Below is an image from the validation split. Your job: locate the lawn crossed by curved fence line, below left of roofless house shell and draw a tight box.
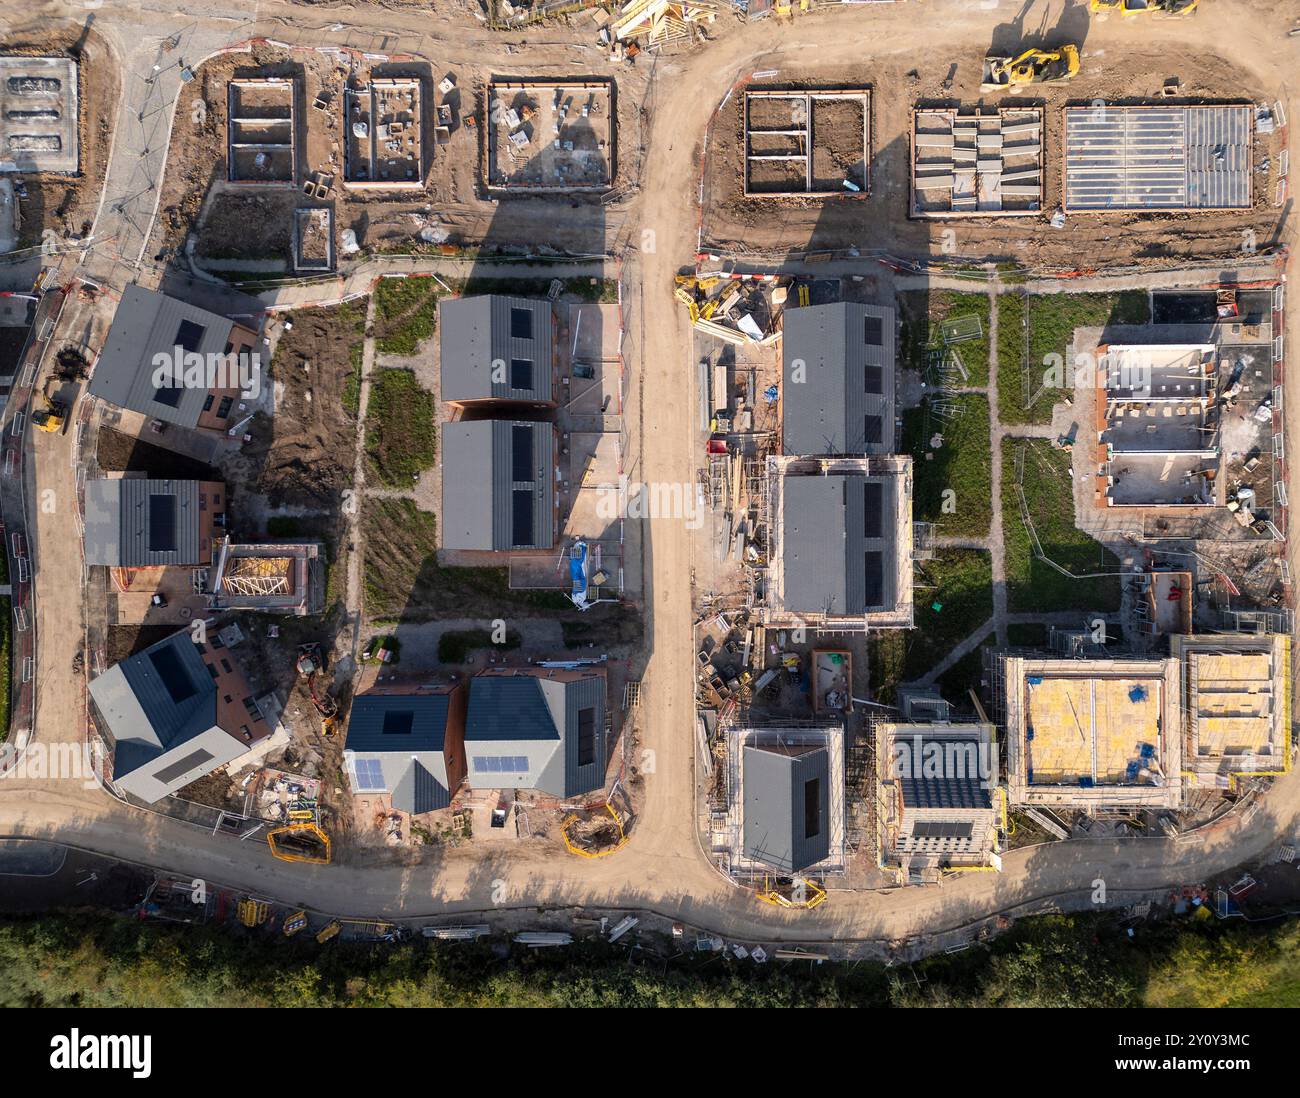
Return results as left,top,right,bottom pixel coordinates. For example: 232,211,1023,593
1002,439,1119,613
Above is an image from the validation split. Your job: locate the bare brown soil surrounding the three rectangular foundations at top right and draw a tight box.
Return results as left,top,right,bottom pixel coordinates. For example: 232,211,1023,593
701,50,1284,269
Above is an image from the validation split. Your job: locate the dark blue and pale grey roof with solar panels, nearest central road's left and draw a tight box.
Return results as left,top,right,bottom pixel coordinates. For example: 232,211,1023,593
465,674,606,798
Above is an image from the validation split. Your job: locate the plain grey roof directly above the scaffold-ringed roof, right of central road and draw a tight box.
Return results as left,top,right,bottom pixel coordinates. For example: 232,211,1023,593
781,301,894,456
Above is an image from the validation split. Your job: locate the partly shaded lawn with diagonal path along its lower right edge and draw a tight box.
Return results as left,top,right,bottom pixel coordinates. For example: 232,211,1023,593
868,550,993,704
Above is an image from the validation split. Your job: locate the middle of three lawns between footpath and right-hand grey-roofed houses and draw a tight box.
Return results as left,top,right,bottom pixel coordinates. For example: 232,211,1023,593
902,394,993,538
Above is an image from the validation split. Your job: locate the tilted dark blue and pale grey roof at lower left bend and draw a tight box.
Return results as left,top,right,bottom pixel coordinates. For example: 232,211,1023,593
90,630,217,781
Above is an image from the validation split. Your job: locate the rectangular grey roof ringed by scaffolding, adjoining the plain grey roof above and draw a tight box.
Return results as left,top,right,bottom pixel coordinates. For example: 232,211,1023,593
781,476,898,617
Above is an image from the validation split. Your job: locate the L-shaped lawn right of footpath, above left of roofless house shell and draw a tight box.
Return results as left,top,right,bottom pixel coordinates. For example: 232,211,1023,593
997,290,1151,424
